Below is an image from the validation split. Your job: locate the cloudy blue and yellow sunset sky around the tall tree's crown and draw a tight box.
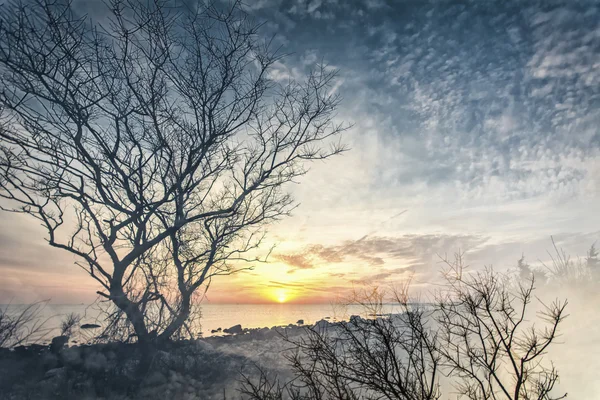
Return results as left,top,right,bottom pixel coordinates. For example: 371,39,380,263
0,0,600,303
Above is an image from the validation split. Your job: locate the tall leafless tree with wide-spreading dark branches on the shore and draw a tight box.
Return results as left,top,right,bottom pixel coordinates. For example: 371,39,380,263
0,0,345,343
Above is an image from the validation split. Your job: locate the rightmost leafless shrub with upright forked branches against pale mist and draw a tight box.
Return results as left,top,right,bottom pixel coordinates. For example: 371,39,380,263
436,254,567,400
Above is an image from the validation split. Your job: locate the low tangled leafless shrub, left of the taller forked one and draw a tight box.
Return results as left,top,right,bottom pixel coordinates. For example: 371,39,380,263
242,286,441,400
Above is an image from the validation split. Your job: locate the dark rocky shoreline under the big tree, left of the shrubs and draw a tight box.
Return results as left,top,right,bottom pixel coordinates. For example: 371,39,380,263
0,319,332,400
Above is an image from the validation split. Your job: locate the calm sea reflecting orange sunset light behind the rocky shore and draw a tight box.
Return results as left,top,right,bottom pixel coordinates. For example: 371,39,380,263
0,303,408,340
